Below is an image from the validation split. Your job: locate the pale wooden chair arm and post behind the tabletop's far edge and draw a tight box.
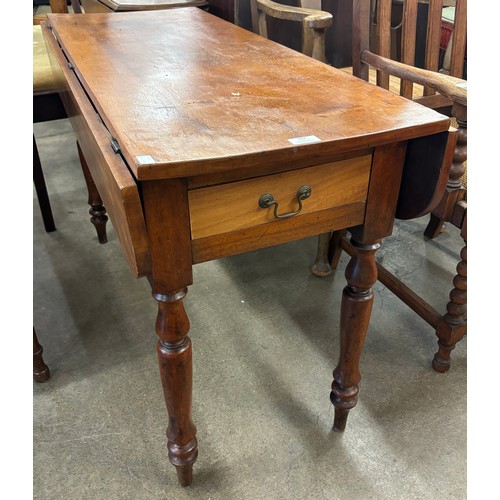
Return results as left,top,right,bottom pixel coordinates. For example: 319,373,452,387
250,0,332,62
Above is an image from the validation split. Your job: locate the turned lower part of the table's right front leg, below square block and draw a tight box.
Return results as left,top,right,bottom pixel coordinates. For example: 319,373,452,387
330,238,380,431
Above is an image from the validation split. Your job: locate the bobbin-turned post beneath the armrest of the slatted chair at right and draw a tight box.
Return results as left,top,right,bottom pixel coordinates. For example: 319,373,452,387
424,105,467,238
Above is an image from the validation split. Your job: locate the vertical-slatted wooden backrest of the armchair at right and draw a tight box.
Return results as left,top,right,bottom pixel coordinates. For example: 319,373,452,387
353,0,467,108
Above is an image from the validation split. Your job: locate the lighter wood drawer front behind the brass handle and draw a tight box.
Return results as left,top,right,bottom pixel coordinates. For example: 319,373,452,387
189,155,372,240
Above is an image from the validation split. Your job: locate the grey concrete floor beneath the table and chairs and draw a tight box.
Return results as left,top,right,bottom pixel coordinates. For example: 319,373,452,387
33,120,467,500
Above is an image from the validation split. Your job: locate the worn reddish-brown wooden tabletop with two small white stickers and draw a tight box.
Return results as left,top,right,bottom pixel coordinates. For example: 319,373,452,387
45,8,449,179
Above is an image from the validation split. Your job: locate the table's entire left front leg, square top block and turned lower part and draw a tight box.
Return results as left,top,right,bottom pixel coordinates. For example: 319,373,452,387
142,179,198,486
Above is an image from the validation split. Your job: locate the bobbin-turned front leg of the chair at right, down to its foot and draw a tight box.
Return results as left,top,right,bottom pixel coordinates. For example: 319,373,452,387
432,216,467,373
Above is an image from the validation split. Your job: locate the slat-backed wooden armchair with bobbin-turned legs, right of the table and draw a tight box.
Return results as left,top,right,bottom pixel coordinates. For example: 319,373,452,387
313,0,467,372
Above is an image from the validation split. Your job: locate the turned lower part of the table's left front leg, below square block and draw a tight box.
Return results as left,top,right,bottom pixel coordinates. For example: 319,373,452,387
154,289,198,486
